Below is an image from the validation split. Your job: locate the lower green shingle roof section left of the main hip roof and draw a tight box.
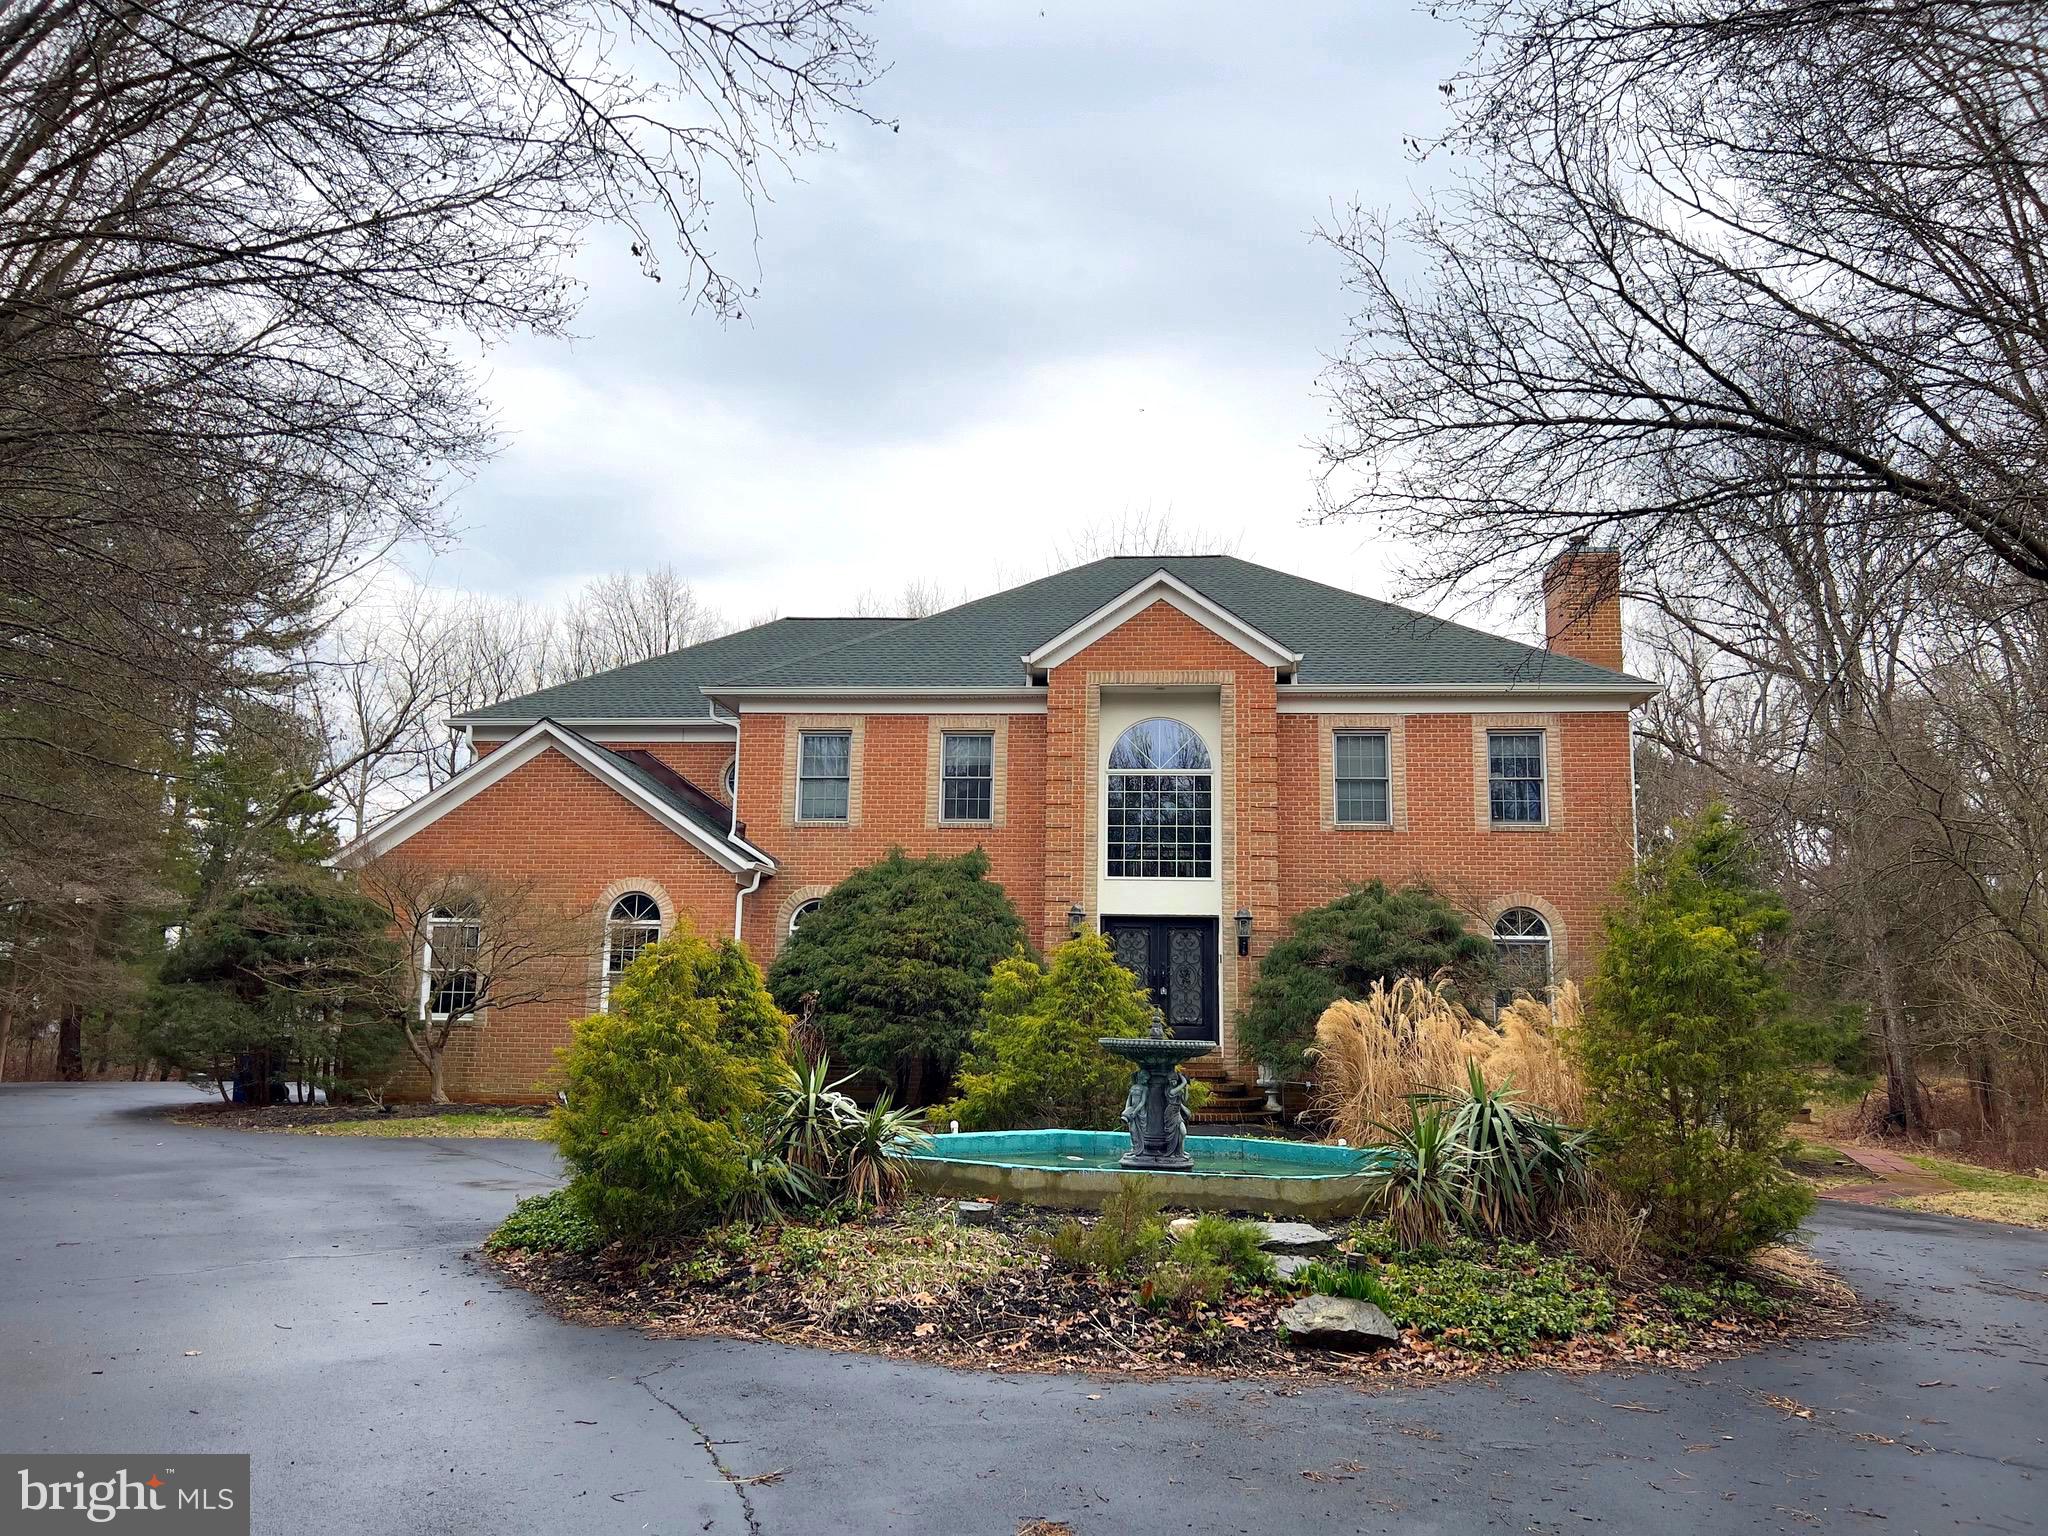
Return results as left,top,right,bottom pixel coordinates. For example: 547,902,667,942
461,618,909,721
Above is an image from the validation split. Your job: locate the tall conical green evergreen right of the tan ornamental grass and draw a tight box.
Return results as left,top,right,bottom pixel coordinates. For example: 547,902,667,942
1577,805,1815,1257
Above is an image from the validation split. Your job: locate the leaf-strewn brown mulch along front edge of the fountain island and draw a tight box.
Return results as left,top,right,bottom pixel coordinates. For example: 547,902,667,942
483,1206,1868,1386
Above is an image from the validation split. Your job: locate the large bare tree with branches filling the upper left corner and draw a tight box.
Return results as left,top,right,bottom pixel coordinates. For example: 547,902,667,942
0,0,874,888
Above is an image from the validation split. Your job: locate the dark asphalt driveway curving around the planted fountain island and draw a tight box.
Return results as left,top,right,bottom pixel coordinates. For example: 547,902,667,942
0,1085,2048,1536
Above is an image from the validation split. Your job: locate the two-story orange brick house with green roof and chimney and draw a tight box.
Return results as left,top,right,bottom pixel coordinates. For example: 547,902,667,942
342,549,1653,1100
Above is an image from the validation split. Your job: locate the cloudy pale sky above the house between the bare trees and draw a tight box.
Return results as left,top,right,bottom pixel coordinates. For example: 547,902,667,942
407,0,1507,634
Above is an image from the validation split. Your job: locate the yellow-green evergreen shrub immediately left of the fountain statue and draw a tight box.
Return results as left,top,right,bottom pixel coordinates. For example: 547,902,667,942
934,934,1151,1130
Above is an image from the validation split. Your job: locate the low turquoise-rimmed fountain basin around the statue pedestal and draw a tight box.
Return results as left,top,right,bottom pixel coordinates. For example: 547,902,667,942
911,1130,1384,1219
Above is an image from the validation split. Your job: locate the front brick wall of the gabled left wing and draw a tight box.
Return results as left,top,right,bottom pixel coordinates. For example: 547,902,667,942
380,750,735,1102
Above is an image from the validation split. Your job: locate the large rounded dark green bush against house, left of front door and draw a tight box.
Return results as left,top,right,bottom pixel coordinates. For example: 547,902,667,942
768,848,1024,1106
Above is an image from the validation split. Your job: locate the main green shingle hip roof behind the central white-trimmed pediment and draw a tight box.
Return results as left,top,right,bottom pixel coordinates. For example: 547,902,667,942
713,555,1655,690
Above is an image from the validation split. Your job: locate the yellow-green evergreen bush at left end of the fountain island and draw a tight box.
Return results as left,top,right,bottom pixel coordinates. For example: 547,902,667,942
555,928,788,1243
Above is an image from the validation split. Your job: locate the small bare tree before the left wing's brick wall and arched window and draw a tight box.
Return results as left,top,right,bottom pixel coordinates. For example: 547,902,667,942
358,856,604,1104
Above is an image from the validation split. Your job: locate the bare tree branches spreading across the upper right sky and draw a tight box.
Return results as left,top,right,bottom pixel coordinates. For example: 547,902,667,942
1325,0,2048,582
